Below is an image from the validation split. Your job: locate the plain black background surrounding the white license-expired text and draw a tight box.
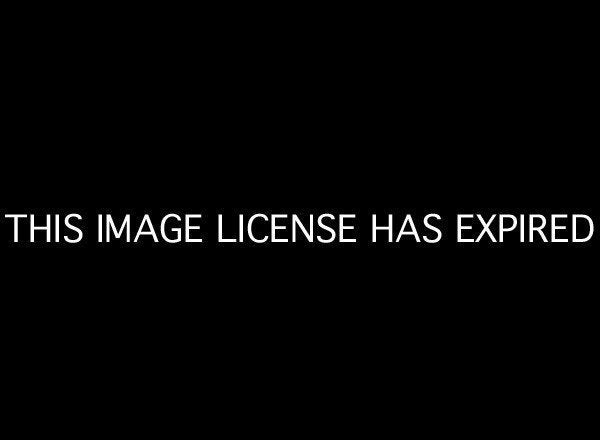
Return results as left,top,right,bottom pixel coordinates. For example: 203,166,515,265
1,5,598,433
